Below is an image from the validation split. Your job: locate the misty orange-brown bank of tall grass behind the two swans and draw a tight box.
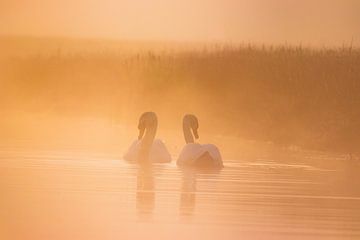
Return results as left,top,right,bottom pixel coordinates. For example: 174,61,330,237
0,37,360,152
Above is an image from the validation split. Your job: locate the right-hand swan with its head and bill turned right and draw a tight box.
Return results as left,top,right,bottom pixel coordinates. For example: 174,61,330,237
177,114,223,168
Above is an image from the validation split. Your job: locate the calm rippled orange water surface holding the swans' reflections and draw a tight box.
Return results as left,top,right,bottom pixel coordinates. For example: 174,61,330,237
0,143,360,240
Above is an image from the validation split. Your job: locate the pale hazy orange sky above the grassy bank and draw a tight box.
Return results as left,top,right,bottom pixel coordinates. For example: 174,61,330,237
0,0,360,45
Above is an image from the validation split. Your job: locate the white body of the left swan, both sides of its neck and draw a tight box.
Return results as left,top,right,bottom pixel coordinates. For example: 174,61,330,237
124,139,171,163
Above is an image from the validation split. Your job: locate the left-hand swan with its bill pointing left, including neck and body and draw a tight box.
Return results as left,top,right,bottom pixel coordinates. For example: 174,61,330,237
124,112,171,163
